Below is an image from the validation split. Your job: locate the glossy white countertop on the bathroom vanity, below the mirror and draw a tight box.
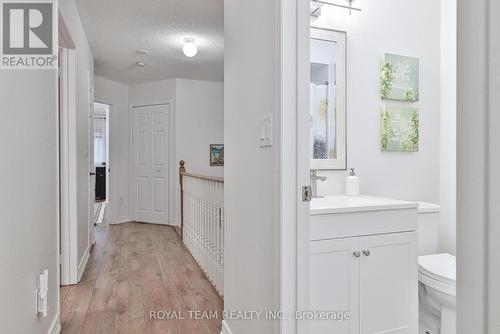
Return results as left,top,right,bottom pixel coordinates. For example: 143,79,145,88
311,195,419,215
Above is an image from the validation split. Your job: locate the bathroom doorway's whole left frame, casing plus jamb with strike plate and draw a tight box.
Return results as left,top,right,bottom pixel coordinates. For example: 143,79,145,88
275,0,310,334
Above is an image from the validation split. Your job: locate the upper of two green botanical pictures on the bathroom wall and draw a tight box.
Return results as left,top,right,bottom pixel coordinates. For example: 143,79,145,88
380,53,419,102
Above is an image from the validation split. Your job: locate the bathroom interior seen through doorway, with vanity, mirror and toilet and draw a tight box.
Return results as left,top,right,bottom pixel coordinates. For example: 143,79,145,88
309,0,457,334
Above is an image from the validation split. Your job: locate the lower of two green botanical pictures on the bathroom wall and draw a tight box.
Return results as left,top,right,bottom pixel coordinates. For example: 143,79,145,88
380,107,419,152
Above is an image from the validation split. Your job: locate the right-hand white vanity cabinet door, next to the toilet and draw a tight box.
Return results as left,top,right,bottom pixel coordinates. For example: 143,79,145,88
360,232,418,334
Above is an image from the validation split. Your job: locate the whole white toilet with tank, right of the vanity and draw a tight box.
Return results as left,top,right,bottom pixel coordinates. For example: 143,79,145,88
418,203,456,334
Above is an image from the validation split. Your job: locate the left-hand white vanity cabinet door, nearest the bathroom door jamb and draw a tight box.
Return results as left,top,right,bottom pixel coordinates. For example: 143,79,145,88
309,238,360,334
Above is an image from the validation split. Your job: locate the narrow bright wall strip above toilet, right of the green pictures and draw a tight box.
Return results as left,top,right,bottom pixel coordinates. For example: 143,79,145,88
439,0,457,255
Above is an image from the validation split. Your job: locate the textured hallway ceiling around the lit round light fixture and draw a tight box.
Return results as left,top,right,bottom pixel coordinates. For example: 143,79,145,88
77,0,224,84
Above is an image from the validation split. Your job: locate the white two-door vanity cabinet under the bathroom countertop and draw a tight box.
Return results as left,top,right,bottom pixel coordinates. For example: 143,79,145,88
309,196,418,334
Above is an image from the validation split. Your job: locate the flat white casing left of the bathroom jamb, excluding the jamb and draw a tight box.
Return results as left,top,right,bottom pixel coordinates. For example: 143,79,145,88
276,0,300,334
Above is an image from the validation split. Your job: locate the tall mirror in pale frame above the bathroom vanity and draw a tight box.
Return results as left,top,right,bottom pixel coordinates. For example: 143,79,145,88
309,28,347,170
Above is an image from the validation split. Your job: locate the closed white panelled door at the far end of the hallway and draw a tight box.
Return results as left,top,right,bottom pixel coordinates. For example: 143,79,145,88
132,104,170,224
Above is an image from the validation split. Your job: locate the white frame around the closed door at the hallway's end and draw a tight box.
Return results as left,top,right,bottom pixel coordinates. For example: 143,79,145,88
129,101,174,225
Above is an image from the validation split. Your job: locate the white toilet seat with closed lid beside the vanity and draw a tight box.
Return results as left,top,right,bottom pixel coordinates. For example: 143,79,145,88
418,253,457,296
